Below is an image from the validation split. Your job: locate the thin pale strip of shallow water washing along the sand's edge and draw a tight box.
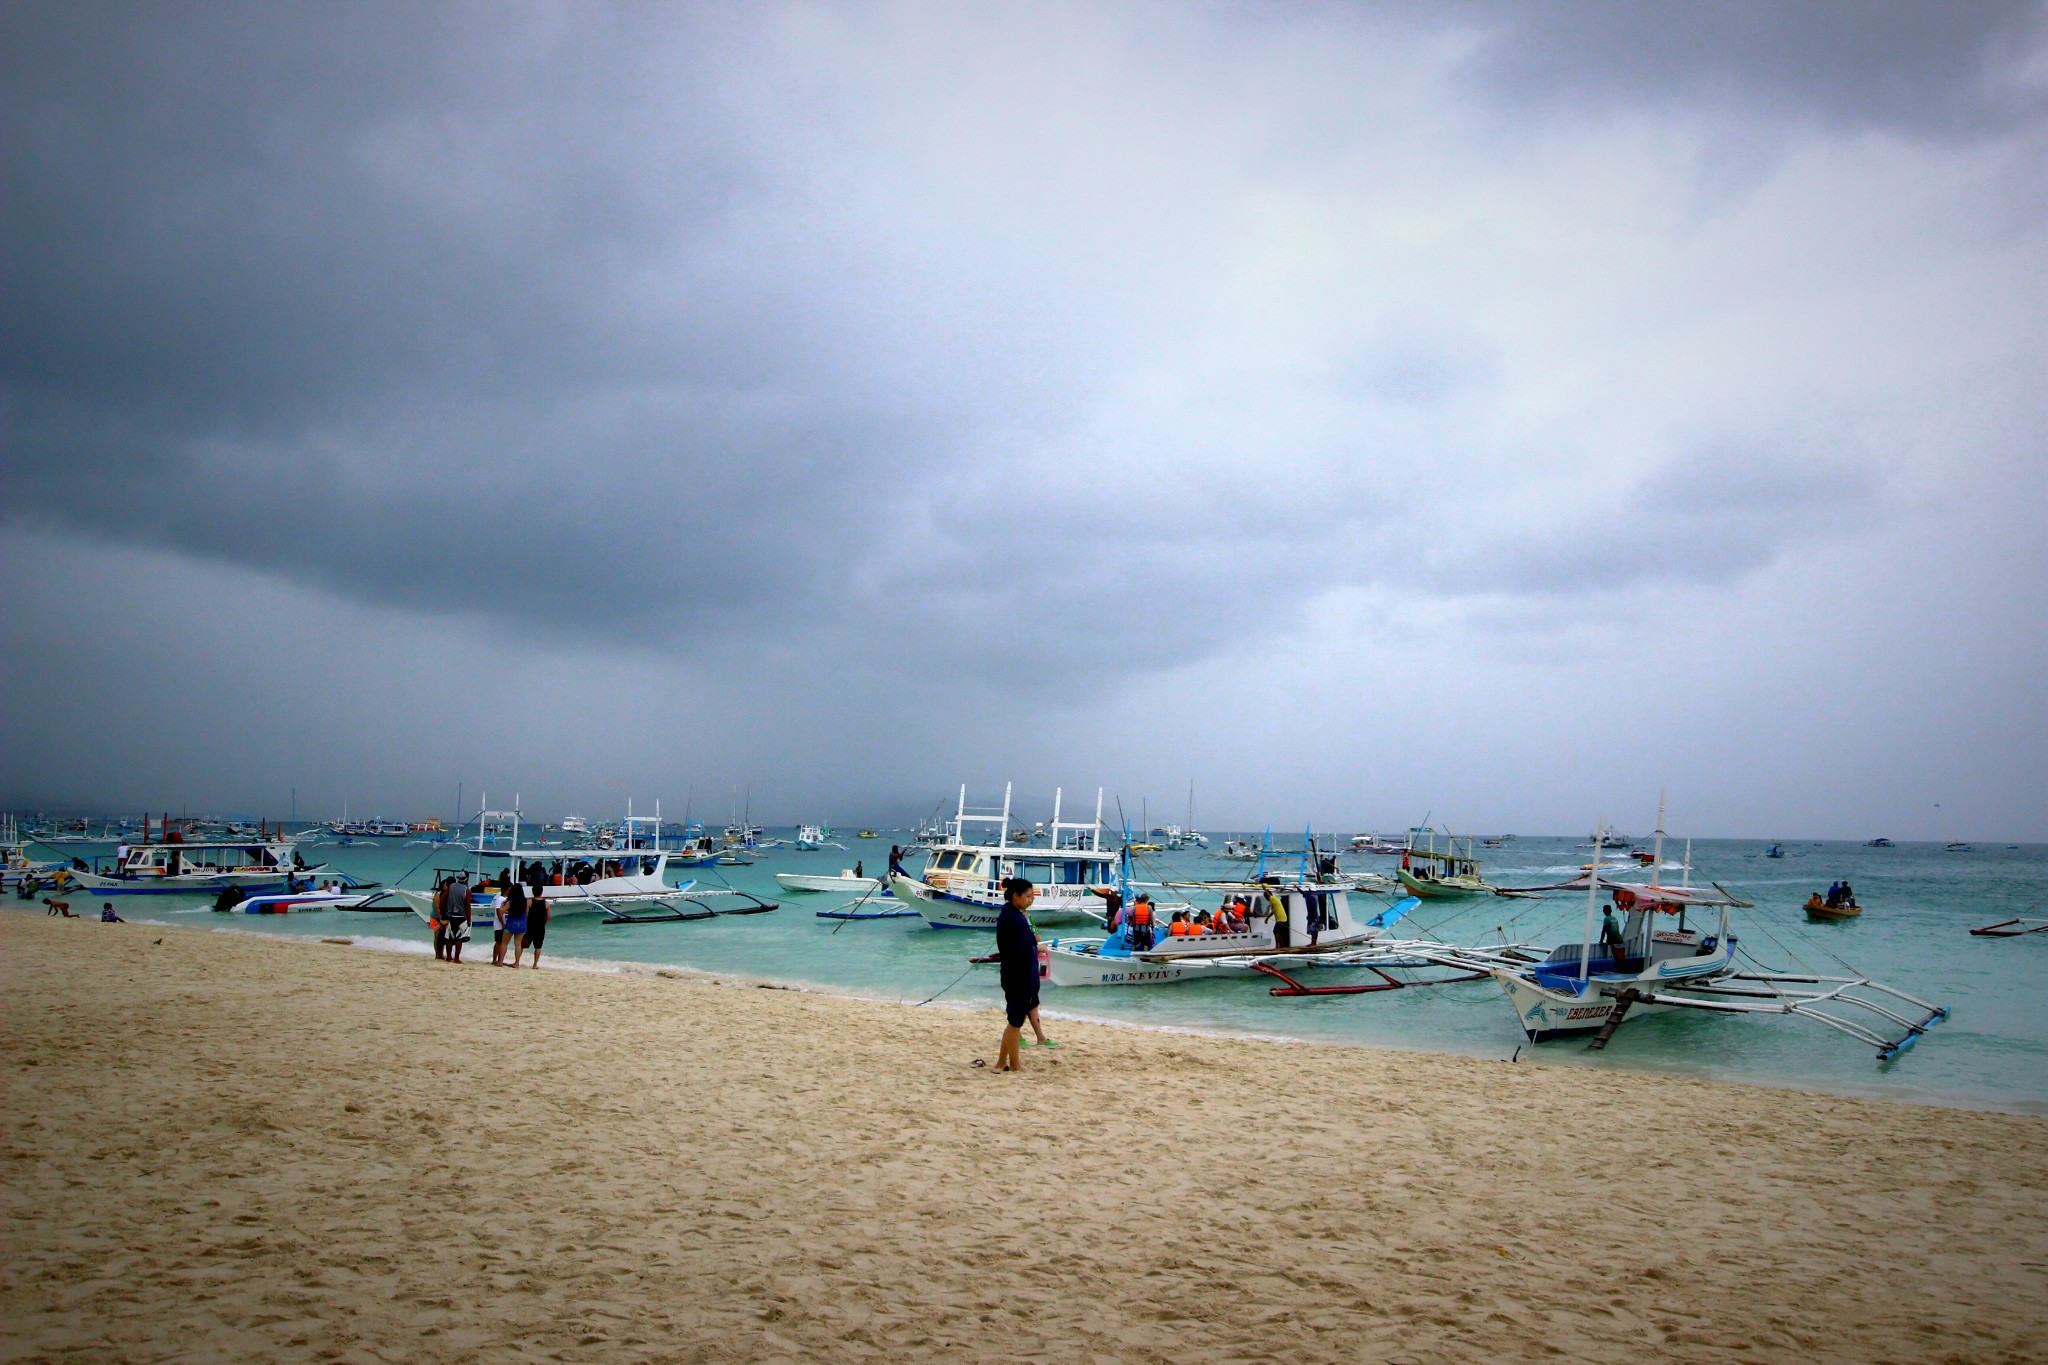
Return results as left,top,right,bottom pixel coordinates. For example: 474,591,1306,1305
151,919,2048,1119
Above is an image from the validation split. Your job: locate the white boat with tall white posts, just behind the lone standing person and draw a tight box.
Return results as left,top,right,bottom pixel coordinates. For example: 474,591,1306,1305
889,784,1118,929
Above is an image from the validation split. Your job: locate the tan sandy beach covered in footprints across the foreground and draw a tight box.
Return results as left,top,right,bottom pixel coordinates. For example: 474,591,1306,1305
0,915,2048,1361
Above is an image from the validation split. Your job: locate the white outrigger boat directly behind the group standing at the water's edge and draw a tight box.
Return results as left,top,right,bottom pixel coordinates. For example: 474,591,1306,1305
391,806,776,923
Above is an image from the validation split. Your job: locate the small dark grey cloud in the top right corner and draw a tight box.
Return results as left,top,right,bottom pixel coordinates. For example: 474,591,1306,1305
1473,0,2048,137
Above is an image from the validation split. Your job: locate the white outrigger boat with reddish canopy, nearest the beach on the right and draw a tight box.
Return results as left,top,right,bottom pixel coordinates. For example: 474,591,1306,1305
1419,819,1948,1062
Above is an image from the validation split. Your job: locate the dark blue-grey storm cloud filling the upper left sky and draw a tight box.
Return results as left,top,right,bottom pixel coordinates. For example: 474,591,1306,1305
0,6,974,642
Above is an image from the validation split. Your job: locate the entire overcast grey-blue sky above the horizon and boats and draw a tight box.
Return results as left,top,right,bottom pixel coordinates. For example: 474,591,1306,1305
0,2,2048,839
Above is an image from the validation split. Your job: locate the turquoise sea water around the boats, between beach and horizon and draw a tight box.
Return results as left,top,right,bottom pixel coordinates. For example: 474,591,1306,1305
24,831,2048,1113
